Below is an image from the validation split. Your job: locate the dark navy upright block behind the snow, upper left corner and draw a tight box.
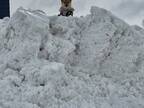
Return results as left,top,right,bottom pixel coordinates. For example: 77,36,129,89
0,0,10,19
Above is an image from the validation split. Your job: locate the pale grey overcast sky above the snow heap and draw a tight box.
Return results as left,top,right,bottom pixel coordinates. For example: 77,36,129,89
11,0,144,26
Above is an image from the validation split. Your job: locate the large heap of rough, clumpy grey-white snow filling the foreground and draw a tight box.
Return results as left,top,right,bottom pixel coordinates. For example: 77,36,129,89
0,7,144,108
